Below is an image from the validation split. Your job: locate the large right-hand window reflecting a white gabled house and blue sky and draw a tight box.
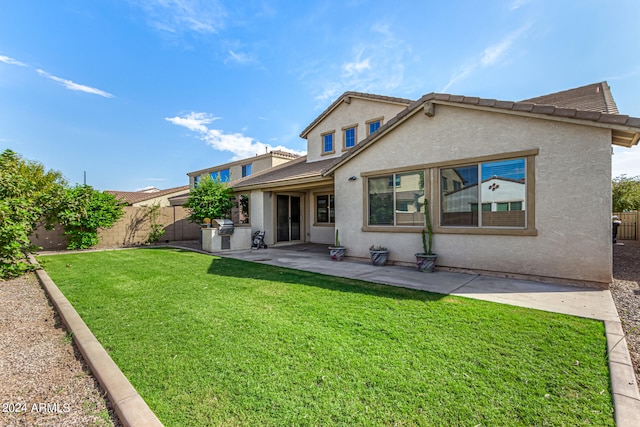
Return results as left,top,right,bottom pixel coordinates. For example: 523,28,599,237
439,158,527,228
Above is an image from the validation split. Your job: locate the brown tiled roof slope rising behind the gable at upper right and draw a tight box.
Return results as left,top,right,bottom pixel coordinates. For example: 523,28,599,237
520,82,619,114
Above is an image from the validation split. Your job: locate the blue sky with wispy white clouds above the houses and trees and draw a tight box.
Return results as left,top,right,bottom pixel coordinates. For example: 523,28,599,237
0,0,640,190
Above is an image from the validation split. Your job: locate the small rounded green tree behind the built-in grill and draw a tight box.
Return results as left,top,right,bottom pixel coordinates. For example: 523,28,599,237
185,177,235,223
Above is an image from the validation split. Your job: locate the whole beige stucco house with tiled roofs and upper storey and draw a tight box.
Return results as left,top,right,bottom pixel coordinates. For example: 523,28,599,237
232,82,640,285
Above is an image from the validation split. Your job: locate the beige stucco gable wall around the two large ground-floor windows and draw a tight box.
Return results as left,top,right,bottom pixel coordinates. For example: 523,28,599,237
335,105,612,283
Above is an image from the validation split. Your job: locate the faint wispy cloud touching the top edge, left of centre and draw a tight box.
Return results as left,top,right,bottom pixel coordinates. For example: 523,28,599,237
137,0,227,34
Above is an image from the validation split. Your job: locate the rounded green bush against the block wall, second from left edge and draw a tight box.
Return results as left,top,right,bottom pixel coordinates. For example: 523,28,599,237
58,185,123,249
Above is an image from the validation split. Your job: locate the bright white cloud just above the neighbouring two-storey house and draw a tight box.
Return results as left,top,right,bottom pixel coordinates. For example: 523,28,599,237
165,112,304,160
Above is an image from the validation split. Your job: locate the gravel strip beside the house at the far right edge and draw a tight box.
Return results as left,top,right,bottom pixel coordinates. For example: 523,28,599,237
611,240,640,384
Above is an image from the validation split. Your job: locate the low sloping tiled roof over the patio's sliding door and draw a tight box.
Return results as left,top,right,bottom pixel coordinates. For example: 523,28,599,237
232,156,339,190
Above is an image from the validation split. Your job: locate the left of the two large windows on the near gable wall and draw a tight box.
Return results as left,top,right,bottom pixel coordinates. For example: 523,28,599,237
367,171,425,227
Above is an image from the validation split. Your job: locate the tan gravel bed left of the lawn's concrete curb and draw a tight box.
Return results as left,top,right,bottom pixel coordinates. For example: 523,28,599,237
0,274,120,427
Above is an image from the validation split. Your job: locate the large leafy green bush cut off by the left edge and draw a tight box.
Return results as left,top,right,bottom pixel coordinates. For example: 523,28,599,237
0,149,66,279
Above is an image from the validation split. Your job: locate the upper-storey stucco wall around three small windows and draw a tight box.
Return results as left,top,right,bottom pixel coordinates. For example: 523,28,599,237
307,98,406,162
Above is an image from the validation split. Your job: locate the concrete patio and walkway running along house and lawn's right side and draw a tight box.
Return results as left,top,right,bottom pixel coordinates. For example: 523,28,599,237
196,244,640,427
